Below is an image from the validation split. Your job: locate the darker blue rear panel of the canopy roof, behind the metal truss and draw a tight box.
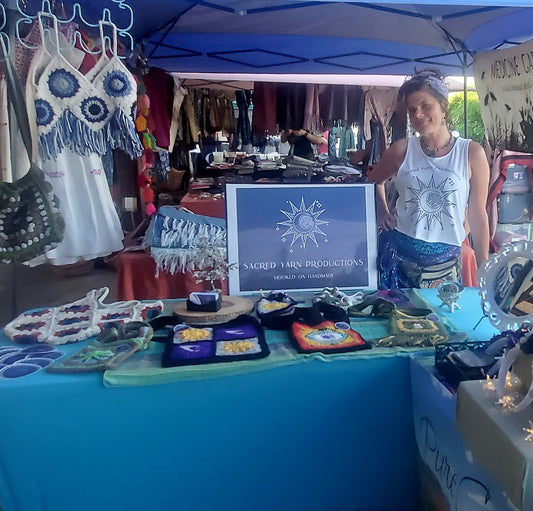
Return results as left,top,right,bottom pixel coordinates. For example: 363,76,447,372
143,34,461,74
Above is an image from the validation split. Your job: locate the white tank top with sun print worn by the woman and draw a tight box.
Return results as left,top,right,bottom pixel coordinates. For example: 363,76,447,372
395,137,470,246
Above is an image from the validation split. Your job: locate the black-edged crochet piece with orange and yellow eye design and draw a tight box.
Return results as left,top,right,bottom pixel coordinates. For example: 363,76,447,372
290,320,371,353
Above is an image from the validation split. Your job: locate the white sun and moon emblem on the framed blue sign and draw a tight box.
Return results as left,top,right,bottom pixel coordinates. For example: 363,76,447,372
276,197,329,252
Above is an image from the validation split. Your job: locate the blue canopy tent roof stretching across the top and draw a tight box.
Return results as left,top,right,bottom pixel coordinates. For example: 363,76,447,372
15,0,533,74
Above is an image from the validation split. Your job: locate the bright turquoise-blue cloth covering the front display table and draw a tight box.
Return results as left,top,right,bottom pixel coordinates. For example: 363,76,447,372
0,289,498,511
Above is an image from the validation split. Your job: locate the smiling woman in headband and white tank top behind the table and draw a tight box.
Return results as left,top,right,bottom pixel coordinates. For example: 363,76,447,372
368,70,489,288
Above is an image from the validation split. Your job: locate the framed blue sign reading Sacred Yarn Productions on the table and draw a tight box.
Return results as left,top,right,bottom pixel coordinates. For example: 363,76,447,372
226,184,377,295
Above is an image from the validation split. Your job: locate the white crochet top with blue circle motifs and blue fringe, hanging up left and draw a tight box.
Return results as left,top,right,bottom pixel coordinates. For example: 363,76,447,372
32,43,142,159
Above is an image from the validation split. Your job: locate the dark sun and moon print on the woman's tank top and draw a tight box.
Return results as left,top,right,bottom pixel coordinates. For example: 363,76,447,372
405,176,455,229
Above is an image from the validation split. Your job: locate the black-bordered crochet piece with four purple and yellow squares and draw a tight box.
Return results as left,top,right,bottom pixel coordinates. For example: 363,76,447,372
162,314,270,367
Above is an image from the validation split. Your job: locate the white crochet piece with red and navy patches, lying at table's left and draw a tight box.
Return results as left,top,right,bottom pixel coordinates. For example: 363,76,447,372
4,287,164,345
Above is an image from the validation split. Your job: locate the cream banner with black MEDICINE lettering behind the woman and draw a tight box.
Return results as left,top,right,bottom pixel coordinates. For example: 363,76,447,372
474,40,533,152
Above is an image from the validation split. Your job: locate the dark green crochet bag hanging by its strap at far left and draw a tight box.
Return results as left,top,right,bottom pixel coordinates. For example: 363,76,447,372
0,39,65,262
